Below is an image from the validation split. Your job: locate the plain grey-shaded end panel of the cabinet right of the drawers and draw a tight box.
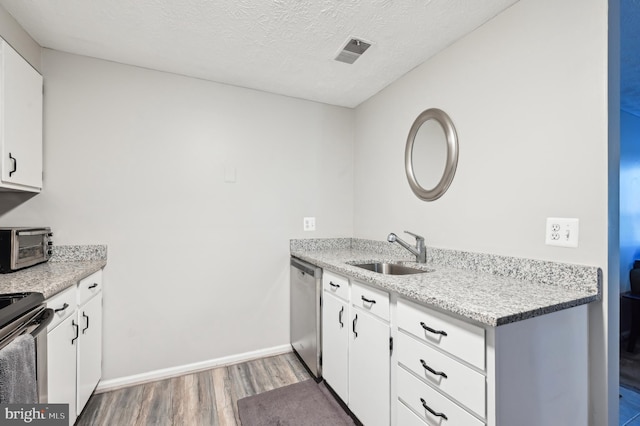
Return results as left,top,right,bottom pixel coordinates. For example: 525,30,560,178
487,305,589,426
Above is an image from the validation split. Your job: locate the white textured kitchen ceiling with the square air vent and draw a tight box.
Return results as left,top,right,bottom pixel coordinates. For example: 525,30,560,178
0,0,517,107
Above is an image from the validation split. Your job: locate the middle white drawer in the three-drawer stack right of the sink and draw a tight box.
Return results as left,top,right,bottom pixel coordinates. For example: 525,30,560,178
396,332,486,417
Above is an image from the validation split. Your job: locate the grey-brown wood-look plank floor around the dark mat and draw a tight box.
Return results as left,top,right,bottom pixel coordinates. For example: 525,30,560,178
76,353,310,426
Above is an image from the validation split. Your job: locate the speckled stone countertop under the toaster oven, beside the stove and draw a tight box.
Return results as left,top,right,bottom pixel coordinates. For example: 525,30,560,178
0,246,107,299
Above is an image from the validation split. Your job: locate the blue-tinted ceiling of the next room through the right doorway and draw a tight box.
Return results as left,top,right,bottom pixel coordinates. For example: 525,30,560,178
620,0,640,117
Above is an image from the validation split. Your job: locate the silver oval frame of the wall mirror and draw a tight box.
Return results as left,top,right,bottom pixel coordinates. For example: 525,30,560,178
404,108,458,201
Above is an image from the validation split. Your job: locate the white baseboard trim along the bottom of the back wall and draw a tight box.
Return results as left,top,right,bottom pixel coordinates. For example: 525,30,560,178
95,344,292,393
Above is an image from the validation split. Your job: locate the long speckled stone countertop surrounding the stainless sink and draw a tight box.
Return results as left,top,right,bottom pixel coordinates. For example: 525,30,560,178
291,238,602,326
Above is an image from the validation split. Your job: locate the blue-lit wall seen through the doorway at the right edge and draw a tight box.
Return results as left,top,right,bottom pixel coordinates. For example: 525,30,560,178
620,111,640,291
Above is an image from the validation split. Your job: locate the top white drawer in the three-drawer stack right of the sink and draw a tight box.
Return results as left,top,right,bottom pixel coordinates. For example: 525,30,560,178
398,300,485,370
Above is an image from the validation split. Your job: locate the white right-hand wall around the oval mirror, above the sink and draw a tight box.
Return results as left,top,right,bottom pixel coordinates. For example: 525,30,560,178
354,0,618,425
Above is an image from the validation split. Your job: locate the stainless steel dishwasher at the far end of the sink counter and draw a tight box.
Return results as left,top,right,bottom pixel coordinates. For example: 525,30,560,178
289,257,322,380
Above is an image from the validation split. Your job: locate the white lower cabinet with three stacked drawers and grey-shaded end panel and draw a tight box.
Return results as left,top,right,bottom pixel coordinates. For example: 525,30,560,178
393,300,588,426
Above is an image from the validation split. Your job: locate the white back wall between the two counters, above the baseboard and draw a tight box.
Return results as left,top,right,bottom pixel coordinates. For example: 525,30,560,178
0,49,354,379
